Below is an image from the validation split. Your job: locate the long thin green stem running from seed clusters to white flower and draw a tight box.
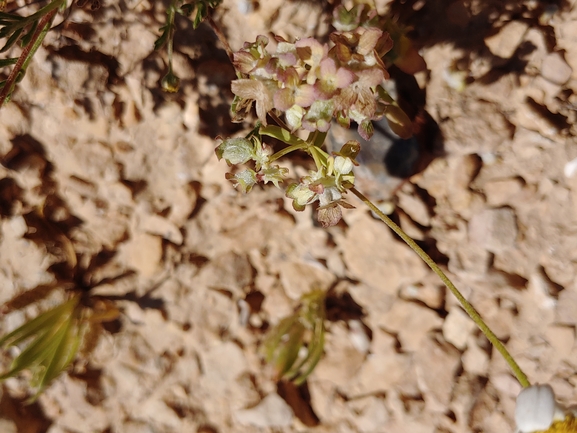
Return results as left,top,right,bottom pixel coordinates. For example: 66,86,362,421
351,187,531,387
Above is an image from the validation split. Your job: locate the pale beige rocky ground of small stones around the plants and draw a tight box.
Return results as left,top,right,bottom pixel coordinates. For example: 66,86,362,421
0,0,577,433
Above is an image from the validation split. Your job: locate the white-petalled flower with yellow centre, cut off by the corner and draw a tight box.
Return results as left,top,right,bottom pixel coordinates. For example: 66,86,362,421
515,385,577,433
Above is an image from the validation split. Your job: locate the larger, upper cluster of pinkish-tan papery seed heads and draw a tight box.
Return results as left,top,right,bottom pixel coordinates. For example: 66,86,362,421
232,27,412,140
